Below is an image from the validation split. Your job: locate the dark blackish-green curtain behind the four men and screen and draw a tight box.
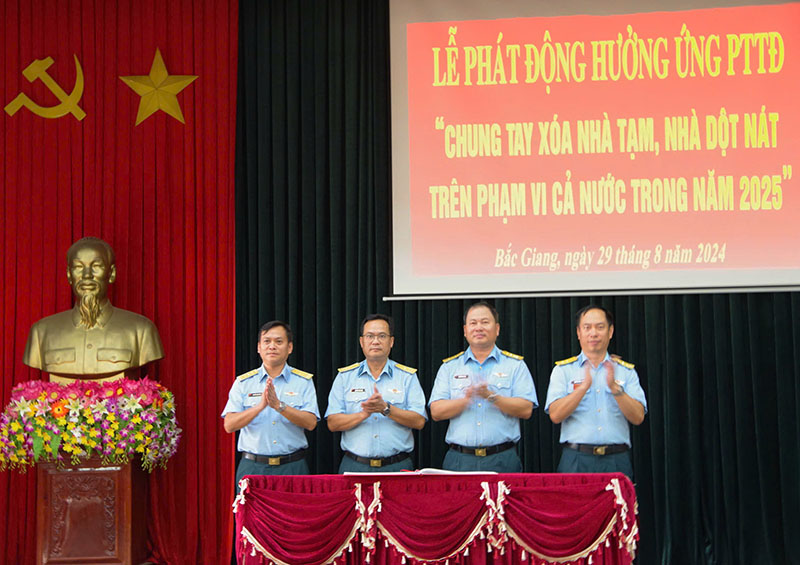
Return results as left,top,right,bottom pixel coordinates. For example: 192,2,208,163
230,0,800,564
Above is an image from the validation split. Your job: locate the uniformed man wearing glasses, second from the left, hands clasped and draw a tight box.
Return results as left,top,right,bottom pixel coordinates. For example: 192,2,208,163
325,314,427,473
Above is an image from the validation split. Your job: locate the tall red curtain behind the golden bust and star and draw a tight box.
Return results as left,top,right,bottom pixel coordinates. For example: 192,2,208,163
0,0,238,564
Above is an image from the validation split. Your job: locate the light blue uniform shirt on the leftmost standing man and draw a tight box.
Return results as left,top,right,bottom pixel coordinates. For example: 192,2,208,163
222,365,319,456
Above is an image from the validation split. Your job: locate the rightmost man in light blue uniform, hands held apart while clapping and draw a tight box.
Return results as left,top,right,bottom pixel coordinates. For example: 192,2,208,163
544,305,647,479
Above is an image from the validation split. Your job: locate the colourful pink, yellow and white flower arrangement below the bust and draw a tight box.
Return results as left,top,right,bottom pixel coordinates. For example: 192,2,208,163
0,379,181,471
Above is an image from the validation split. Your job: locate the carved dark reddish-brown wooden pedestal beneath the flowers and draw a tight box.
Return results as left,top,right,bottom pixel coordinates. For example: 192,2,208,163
36,459,147,565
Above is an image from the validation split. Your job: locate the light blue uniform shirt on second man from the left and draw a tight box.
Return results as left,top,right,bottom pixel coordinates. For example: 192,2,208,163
325,359,428,458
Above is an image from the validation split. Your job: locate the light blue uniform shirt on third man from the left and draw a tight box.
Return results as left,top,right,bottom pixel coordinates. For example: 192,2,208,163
428,346,539,447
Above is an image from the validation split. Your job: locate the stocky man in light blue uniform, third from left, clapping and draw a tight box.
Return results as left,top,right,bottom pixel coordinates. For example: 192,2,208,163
430,301,538,473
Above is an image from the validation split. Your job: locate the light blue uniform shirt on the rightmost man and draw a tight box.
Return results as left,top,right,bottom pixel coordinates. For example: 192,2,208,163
544,352,647,446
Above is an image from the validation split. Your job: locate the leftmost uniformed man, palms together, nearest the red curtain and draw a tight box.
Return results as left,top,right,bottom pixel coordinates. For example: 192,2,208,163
222,320,319,485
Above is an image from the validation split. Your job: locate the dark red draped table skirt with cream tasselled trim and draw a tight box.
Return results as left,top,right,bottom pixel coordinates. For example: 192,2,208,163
234,473,639,565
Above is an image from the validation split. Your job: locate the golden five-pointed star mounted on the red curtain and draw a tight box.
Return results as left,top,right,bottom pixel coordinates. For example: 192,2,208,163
119,48,197,126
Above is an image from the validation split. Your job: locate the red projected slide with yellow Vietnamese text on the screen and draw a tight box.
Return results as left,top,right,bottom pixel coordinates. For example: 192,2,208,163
395,4,800,293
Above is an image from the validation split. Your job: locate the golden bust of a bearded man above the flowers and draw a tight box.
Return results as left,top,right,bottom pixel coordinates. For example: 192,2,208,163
22,237,164,382
